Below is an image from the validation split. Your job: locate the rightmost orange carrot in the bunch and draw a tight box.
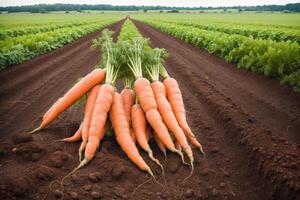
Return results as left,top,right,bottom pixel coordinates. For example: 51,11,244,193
163,77,205,155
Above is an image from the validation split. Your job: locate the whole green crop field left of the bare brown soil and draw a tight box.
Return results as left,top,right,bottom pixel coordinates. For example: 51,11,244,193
0,14,122,70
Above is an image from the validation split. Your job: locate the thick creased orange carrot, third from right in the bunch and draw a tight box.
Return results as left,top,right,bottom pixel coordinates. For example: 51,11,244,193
134,78,184,162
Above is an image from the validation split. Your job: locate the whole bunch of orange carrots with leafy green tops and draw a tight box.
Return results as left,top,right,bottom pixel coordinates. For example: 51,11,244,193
31,20,204,184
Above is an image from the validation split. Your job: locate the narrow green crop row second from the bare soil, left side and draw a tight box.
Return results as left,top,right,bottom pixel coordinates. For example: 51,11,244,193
0,22,102,40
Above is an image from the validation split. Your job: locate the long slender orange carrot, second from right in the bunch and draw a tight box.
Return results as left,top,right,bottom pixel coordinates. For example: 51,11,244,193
151,81,194,170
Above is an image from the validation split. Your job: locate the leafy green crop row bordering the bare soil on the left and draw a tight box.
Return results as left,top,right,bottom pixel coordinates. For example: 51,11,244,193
0,19,117,70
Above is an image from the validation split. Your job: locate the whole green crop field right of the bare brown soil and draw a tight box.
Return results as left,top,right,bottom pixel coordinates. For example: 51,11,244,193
134,14,300,91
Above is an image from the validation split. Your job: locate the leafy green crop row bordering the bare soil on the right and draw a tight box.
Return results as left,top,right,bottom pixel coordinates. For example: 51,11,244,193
139,20,300,91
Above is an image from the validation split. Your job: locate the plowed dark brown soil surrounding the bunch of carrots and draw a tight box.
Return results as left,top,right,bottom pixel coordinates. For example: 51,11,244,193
0,21,300,200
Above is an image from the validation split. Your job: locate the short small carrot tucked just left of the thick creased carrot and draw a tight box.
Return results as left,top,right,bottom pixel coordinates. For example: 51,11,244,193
131,104,164,174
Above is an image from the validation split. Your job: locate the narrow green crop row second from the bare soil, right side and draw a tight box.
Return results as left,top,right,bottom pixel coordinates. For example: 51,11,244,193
171,22,300,44
